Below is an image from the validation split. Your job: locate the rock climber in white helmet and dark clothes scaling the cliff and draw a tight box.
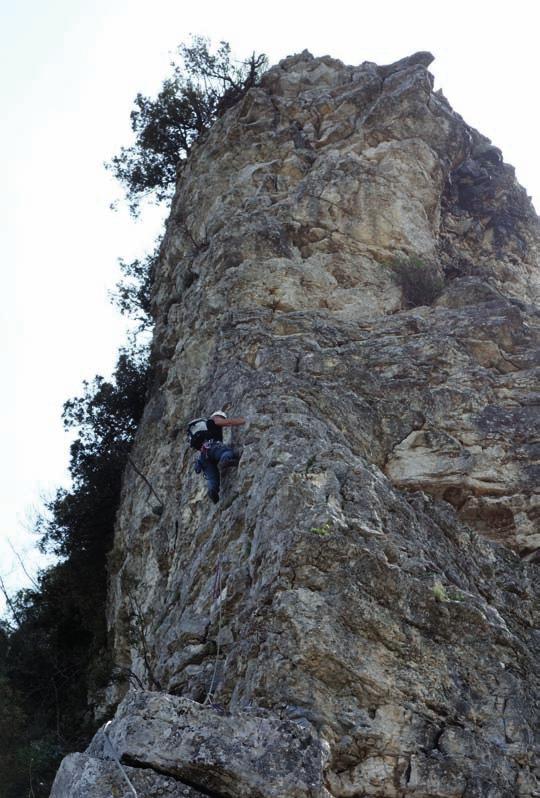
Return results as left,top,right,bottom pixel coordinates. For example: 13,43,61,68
187,410,246,504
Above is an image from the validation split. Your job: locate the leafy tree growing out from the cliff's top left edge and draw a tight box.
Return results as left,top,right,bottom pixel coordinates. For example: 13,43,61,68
107,36,267,214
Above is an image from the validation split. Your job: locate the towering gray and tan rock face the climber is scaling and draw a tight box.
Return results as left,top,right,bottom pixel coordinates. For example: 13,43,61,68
53,52,540,798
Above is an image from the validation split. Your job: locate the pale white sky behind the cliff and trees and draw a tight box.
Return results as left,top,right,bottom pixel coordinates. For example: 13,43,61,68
0,0,540,612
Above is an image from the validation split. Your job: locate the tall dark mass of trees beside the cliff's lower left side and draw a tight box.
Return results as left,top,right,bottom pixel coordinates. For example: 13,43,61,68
0,349,148,798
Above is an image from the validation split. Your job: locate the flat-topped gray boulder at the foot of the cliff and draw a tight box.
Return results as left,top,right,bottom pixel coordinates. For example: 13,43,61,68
100,692,328,798
